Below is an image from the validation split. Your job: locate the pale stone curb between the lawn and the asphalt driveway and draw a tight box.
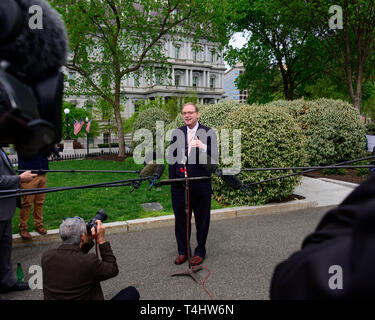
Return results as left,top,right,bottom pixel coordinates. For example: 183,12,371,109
12,200,318,247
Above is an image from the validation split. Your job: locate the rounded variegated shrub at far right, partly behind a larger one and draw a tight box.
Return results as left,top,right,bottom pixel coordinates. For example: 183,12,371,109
264,99,366,166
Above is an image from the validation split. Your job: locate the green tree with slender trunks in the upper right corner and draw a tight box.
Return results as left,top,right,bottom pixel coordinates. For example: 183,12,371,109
281,0,375,111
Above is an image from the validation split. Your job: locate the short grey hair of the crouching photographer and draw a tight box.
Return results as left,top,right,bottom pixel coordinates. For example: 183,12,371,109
59,217,87,245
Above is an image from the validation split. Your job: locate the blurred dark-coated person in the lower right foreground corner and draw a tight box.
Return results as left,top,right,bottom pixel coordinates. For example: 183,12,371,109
270,174,375,300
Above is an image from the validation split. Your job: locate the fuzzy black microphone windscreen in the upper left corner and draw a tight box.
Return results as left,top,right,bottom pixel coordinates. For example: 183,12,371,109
0,0,68,80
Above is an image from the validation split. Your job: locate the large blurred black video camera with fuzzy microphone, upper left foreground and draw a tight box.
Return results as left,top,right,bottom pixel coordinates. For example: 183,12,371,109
0,0,68,157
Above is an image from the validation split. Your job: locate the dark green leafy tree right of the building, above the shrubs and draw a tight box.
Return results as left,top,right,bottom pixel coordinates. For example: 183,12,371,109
226,0,324,103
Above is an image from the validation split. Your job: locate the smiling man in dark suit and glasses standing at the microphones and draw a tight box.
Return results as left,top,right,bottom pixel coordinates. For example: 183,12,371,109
168,102,217,266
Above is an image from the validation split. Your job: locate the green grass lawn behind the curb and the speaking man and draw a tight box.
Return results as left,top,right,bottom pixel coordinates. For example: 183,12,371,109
13,157,228,233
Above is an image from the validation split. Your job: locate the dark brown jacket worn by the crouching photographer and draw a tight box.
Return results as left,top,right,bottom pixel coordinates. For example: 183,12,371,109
42,242,118,300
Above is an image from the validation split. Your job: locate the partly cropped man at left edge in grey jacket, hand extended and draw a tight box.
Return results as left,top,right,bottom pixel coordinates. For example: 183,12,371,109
0,148,36,293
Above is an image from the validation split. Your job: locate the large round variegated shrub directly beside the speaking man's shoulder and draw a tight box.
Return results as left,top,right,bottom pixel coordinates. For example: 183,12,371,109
213,105,307,205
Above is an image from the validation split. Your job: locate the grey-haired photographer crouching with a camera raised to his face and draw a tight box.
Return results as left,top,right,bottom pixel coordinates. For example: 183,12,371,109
42,210,139,300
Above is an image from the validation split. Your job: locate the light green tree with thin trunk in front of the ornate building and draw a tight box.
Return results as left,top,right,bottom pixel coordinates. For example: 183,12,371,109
51,0,225,156
